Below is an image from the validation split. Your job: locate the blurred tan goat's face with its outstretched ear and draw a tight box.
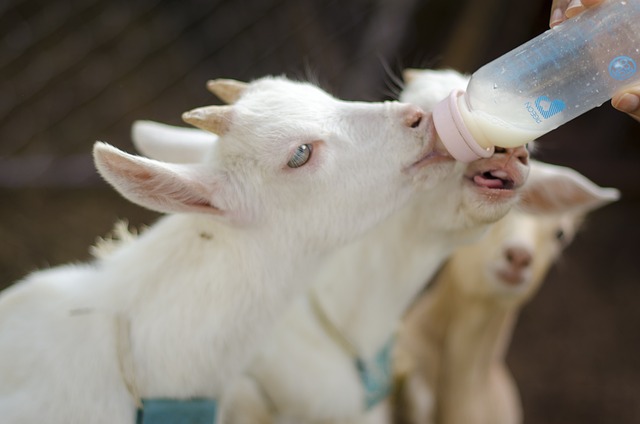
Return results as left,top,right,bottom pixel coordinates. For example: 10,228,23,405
442,161,619,304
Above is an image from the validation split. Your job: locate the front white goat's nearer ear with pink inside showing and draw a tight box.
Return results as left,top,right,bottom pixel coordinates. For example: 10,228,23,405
93,142,238,216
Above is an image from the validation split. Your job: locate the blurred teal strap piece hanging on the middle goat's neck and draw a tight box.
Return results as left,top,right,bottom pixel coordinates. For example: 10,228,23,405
356,338,395,410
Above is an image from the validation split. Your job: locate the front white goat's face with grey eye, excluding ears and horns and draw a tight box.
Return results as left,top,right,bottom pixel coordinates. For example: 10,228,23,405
202,78,451,248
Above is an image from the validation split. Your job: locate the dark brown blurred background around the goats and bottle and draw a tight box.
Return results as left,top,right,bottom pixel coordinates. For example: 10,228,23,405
0,0,640,424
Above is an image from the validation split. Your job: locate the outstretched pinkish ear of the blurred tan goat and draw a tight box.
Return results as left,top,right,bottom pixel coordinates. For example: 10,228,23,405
518,161,620,217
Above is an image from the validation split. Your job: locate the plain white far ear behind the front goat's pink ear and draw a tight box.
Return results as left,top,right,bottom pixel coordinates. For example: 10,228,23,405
131,121,218,163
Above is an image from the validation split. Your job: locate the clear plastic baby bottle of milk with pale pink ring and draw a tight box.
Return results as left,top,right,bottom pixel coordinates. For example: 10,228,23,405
433,0,640,162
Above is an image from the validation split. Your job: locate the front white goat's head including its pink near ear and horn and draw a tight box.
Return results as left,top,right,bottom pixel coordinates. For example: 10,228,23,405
96,77,452,248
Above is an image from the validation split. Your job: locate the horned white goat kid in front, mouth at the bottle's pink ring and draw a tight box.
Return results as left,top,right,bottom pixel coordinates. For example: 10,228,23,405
0,78,441,424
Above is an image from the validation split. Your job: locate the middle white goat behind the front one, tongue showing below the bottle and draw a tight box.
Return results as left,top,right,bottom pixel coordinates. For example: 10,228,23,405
134,70,528,423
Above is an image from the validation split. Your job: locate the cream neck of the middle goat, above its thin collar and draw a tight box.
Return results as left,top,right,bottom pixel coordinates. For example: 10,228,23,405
313,185,484,358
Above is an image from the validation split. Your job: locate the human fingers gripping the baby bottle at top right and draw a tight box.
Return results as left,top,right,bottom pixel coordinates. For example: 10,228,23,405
549,0,640,122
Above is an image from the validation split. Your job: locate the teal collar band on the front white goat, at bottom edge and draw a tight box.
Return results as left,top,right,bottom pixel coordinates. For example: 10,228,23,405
136,399,217,424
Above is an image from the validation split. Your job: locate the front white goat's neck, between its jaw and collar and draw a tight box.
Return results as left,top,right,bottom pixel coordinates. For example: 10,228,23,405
99,214,313,397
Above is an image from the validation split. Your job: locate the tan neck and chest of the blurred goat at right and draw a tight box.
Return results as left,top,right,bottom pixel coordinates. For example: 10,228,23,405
423,267,518,424
